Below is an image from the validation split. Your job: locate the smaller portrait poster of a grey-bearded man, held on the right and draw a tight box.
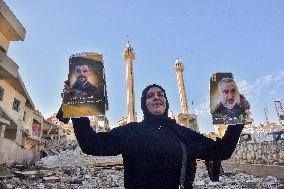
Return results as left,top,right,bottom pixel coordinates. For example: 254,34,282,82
210,73,246,124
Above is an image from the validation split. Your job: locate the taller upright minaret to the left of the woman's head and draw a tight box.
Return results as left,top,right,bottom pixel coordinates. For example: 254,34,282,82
123,41,136,123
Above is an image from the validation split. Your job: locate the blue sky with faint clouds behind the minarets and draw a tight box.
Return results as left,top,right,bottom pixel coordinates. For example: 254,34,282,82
4,0,284,133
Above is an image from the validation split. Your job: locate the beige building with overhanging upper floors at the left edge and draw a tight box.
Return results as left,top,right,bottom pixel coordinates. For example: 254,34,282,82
0,0,43,163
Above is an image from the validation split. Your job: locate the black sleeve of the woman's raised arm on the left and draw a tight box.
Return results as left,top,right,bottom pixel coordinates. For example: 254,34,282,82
72,117,123,156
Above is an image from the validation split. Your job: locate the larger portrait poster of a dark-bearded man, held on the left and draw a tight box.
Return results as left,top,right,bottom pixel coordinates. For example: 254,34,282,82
63,52,108,118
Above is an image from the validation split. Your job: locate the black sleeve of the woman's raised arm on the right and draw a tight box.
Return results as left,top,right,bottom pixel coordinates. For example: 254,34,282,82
184,124,244,161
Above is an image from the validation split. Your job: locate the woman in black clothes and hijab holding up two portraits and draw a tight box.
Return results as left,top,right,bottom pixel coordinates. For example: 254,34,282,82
58,84,246,189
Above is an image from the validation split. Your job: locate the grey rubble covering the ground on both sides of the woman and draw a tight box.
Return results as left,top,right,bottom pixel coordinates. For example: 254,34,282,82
0,142,284,189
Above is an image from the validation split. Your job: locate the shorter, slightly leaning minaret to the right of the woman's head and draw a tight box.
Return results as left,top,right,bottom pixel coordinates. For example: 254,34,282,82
175,58,188,114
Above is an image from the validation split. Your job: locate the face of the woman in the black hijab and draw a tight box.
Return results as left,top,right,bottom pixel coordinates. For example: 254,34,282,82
146,87,166,115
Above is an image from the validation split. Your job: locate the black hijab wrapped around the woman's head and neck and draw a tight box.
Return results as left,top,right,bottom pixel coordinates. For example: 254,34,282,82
141,84,173,125
